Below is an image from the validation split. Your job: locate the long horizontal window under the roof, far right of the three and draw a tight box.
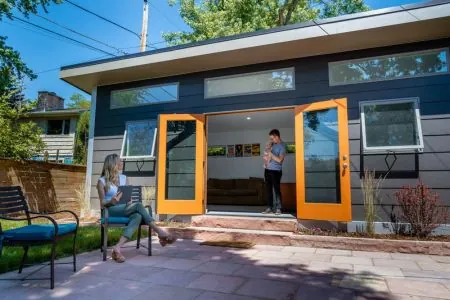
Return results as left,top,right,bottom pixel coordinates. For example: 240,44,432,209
328,48,450,86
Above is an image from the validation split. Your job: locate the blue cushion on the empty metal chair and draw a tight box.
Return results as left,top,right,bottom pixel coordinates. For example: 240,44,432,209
3,223,77,241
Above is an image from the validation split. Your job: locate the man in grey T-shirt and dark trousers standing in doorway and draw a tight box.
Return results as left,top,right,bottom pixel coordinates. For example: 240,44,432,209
263,129,286,215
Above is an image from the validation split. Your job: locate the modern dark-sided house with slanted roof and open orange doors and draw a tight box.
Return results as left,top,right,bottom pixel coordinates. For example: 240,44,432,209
60,1,450,230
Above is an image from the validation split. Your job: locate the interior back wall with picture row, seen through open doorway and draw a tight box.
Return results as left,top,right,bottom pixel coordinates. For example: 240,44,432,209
208,127,295,183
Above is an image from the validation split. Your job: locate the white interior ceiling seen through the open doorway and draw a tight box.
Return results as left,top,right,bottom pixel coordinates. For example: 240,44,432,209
208,109,294,132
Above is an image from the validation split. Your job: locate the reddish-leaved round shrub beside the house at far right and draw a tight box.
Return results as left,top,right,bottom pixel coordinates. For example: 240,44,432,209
395,182,449,237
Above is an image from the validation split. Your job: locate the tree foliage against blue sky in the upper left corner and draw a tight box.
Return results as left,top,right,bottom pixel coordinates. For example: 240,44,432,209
0,0,62,95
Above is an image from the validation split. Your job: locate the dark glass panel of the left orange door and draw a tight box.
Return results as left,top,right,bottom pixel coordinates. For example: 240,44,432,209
165,121,196,200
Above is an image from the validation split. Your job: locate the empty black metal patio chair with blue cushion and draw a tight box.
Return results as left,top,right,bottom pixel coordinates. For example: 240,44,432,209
0,186,79,289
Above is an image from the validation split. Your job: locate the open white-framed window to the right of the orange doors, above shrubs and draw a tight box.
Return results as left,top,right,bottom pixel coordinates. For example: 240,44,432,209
360,98,423,153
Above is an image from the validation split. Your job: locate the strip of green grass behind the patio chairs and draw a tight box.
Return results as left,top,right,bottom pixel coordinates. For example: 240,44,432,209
0,221,147,273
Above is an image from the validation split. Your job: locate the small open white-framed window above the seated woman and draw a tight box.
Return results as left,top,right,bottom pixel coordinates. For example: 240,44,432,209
120,120,158,160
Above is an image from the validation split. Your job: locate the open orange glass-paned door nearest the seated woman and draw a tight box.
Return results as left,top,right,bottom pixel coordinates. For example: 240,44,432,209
156,114,205,215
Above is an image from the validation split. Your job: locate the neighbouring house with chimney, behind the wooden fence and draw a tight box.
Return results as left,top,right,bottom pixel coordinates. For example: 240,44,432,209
27,91,86,164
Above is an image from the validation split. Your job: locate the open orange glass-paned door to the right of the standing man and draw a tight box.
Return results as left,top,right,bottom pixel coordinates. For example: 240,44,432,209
295,99,352,221
